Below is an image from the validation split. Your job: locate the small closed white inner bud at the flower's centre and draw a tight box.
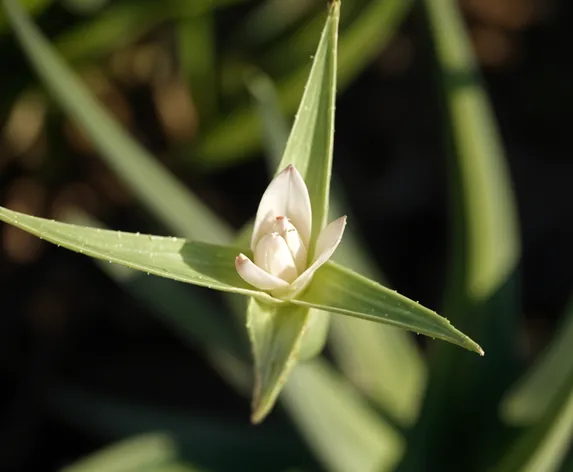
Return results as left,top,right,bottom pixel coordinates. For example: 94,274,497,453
255,233,298,282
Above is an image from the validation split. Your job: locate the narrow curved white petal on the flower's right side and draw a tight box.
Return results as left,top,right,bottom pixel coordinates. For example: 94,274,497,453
272,216,346,299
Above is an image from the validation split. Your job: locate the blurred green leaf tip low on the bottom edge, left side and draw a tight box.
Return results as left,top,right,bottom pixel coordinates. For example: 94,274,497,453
60,433,177,472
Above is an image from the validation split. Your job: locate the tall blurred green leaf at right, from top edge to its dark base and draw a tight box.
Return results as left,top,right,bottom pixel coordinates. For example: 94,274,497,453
400,0,519,472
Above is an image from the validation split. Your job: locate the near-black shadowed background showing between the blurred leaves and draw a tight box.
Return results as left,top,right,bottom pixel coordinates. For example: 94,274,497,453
0,0,573,470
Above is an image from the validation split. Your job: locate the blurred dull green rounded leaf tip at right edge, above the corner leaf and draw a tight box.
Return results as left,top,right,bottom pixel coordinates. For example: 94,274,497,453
501,299,573,426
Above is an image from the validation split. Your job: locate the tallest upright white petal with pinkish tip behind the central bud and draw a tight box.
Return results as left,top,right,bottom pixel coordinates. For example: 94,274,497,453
251,165,312,251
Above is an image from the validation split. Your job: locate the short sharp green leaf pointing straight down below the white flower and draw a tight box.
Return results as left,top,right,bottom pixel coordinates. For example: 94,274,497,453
247,298,309,423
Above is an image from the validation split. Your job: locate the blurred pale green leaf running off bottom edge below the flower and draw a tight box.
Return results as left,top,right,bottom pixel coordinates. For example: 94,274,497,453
283,359,404,472
